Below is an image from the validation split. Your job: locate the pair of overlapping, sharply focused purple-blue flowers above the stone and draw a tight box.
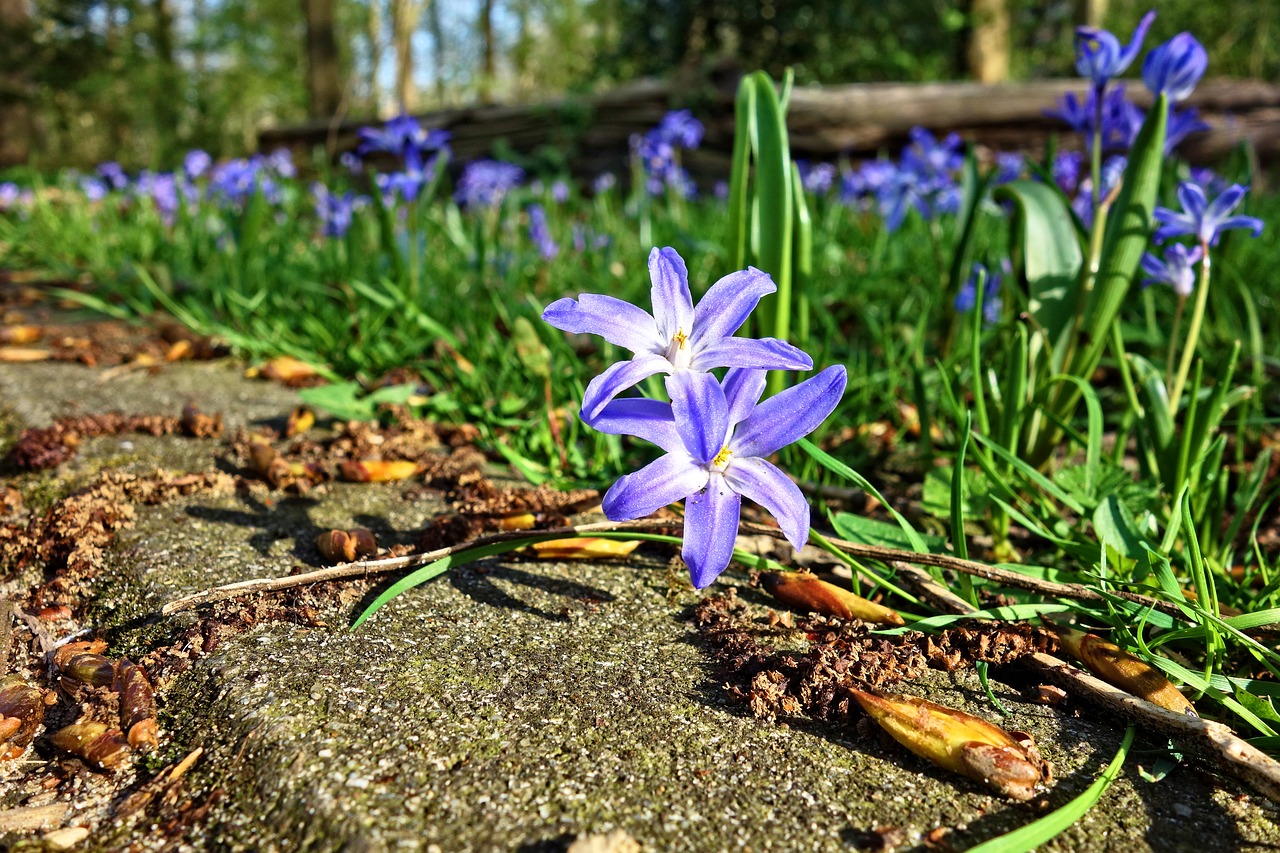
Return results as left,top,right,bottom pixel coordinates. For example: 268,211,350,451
543,248,846,589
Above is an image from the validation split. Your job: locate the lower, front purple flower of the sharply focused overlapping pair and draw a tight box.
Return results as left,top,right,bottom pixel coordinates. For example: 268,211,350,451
593,365,847,589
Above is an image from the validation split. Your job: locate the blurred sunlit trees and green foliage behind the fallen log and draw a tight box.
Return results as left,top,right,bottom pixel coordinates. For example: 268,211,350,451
0,0,1280,168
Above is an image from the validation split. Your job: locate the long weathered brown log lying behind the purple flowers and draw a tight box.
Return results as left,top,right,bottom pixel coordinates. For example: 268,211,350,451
259,79,1280,182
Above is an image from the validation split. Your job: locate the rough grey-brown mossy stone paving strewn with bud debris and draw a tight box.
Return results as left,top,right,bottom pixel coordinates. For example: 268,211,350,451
0,364,1280,852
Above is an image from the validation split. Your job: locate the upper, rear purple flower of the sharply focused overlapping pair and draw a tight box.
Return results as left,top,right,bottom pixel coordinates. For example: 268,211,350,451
543,247,813,417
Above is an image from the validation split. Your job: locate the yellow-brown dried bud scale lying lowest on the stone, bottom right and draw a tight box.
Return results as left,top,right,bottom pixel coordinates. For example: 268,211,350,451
850,689,1044,800
